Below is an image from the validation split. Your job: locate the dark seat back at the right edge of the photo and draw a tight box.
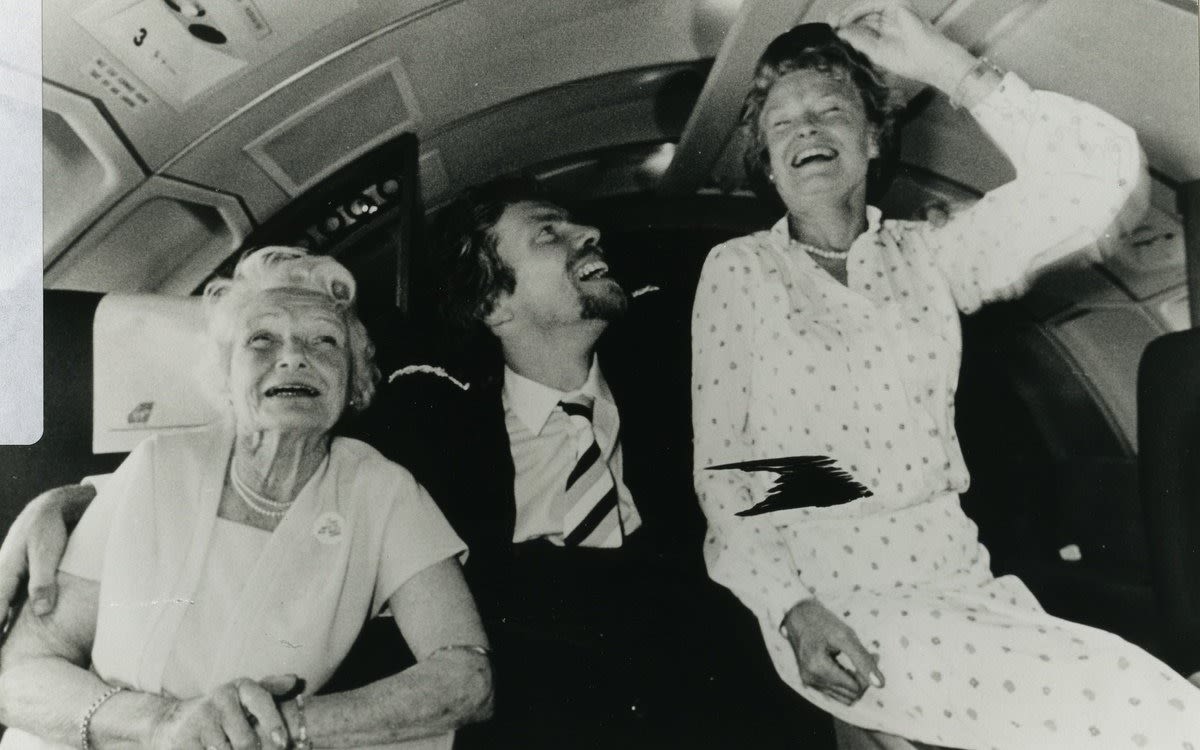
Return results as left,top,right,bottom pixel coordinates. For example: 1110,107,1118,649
1138,329,1200,674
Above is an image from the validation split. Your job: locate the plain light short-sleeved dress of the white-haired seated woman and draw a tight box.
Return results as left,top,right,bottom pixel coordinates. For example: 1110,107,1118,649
2,427,466,750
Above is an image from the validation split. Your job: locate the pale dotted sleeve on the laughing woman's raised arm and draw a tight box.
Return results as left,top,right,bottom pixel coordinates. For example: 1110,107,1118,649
922,73,1150,312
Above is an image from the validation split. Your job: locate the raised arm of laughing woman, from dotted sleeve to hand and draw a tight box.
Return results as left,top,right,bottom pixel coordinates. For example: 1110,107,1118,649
838,0,1150,312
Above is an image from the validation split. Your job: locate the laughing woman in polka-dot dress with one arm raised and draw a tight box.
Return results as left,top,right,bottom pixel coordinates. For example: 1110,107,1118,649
692,0,1200,750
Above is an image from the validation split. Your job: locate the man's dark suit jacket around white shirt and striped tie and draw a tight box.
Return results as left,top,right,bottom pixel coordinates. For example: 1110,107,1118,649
328,285,825,748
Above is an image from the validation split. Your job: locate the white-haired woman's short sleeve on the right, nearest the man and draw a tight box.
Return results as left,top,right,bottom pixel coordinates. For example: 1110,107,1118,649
371,467,467,617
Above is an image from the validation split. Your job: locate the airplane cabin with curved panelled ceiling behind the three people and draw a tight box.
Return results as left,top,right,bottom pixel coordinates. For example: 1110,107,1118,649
0,0,1200,744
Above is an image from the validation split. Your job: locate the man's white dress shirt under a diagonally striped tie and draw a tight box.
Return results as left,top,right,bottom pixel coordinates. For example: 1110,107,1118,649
503,358,642,544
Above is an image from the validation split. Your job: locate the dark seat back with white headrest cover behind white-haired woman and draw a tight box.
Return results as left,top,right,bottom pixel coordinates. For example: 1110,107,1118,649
0,289,220,529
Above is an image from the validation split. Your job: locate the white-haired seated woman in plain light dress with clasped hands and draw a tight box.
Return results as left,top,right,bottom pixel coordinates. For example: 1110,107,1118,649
0,247,491,749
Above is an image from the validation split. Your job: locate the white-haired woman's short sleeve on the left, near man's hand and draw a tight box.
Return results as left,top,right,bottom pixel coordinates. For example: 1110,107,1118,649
59,437,155,581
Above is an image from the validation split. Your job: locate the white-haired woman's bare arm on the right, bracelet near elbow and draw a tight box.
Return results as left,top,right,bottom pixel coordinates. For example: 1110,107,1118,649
283,558,492,748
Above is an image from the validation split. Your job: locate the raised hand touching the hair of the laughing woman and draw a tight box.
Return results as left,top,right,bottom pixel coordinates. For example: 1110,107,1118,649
829,0,977,94
